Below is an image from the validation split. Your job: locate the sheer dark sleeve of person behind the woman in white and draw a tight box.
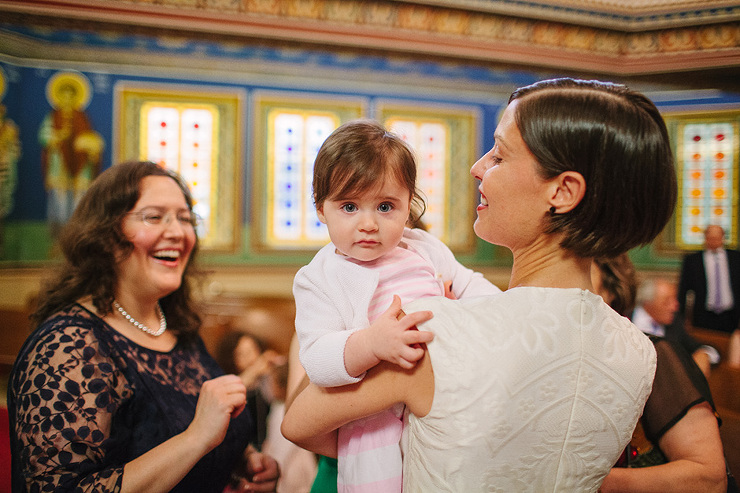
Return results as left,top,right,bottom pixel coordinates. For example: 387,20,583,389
642,338,714,444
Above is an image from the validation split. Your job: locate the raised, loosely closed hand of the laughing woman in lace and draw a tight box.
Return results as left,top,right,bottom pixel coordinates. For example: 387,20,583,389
186,375,247,452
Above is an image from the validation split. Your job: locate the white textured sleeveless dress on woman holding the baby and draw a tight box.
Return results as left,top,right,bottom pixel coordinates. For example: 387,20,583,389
402,287,656,493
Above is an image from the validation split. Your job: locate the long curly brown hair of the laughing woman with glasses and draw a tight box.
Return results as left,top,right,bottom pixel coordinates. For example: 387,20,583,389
31,161,201,335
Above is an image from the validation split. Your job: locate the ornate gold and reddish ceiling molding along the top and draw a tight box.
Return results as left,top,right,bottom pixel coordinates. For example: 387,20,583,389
0,0,740,75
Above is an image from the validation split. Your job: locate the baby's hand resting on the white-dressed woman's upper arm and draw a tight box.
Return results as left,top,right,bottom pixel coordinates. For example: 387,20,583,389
367,296,434,370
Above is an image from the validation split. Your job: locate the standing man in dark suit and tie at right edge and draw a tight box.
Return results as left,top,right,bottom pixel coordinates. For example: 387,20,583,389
678,225,740,333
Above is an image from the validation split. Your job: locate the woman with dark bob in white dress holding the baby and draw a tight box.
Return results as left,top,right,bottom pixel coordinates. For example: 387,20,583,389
283,79,676,493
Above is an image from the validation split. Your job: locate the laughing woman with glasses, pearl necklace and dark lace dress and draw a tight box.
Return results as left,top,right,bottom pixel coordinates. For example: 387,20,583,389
8,162,278,493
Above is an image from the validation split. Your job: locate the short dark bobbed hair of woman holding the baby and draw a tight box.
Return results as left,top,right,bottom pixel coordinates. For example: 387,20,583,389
509,78,677,258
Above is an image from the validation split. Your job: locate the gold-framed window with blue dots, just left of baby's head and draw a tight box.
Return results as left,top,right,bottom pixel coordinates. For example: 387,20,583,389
251,92,364,251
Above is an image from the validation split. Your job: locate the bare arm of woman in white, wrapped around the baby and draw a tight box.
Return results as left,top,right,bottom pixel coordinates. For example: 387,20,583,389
281,348,434,455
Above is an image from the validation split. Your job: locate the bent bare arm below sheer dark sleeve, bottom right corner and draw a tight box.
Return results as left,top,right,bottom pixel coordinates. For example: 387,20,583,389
600,402,727,493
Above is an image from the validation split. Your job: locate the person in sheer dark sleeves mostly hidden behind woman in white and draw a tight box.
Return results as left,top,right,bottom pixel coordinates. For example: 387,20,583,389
591,254,729,493
